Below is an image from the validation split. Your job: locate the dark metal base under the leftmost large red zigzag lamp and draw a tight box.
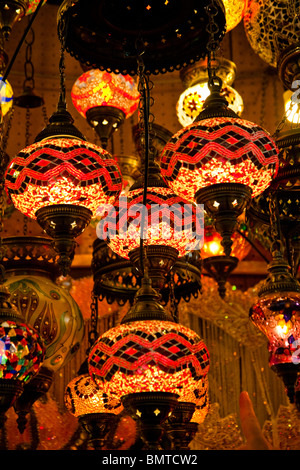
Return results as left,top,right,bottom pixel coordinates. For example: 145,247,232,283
36,204,92,276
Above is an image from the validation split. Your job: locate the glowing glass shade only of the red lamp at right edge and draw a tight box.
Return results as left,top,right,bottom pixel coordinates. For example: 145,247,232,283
250,292,300,367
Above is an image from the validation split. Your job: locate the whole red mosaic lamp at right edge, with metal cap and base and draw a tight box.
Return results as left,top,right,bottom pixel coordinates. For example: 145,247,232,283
250,246,300,403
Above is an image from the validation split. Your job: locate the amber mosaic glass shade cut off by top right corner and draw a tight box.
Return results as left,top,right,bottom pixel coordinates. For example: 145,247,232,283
244,0,300,67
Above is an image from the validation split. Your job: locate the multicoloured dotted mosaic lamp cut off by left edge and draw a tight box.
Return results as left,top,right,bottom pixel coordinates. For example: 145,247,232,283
0,267,44,427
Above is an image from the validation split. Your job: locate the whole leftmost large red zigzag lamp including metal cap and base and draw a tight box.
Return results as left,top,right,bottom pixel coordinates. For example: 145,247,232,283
5,103,122,275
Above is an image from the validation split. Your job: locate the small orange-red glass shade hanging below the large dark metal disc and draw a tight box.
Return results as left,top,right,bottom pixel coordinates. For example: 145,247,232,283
71,69,140,118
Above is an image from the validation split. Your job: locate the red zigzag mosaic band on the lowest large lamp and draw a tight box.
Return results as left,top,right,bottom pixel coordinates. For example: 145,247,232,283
89,321,209,389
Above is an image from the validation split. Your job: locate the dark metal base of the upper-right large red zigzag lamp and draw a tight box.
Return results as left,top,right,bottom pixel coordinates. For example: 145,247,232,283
195,183,252,256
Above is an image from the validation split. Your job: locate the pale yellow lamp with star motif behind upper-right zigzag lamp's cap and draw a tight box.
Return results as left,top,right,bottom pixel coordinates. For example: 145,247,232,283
176,57,244,127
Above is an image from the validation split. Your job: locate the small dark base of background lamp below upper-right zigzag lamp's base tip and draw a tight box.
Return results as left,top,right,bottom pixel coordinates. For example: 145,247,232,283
203,255,239,299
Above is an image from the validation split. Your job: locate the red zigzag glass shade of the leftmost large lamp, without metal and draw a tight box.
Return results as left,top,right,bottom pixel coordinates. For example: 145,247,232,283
5,137,122,219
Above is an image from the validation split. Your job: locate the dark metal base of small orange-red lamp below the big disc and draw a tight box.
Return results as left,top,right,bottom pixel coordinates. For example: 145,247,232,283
86,106,125,149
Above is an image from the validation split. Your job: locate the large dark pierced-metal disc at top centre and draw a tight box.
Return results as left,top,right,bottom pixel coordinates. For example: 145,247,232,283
58,0,226,75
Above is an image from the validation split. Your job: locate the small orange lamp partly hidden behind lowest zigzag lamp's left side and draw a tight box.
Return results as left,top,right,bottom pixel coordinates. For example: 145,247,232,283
64,374,123,450
